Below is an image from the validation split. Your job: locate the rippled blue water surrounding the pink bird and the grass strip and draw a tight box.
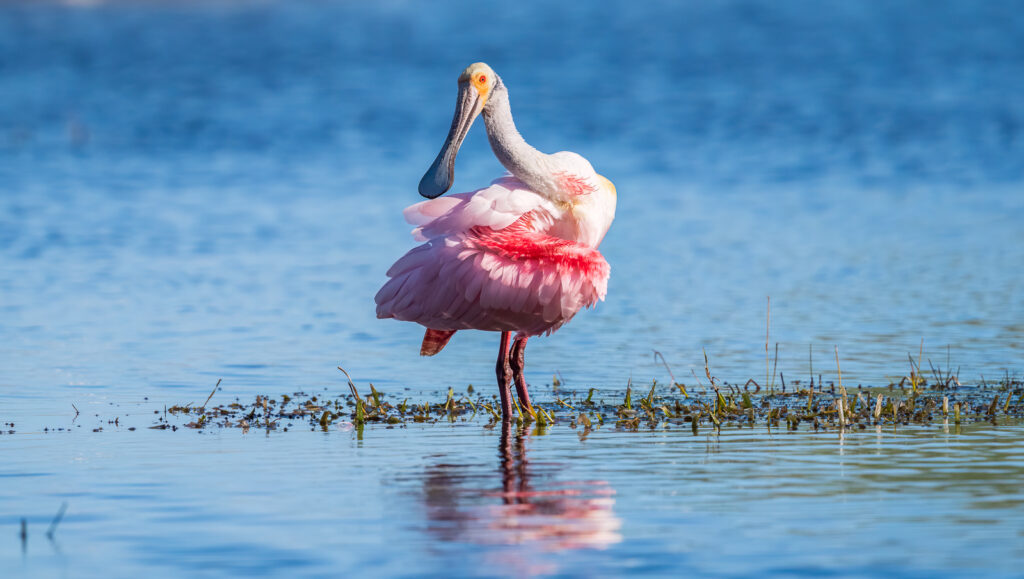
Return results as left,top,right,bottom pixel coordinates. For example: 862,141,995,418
0,1,1024,576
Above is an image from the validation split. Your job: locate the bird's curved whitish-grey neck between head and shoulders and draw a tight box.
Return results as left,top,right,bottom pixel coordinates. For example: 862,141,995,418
483,81,550,191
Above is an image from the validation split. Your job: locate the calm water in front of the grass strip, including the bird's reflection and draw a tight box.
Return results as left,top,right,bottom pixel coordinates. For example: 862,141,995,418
6,419,1024,576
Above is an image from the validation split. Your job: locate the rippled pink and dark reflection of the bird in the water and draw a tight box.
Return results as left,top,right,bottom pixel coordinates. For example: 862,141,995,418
425,421,622,571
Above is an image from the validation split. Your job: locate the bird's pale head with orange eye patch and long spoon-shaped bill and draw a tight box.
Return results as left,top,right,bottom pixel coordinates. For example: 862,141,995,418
420,63,498,199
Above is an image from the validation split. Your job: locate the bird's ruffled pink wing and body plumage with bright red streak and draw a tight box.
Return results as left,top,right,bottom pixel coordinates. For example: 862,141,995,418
376,176,609,336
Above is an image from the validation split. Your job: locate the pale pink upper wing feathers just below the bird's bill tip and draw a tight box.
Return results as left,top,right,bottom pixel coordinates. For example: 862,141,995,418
404,176,550,241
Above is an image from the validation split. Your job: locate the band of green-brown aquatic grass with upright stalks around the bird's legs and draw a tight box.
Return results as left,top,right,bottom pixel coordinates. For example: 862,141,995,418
64,346,1024,437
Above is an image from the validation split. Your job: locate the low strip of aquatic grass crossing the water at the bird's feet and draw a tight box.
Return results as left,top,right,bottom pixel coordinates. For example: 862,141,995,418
132,377,1024,431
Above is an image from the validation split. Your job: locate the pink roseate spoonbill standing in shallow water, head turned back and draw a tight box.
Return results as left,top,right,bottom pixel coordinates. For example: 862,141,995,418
375,63,617,422
